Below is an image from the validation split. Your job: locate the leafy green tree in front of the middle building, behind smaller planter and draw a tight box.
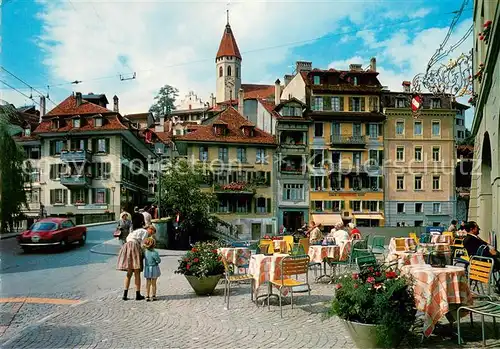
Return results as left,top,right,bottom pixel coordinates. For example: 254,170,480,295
160,159,218,245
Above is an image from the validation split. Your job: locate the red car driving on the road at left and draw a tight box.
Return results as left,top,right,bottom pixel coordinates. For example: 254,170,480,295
17,218,87,252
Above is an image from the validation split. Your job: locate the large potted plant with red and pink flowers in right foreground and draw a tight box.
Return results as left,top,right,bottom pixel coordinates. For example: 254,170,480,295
328,266,417,348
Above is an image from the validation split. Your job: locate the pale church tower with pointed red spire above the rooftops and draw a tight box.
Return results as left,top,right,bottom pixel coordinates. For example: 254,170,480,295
215,11,241,103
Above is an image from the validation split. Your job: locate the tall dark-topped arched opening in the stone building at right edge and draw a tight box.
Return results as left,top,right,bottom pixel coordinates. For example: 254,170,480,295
478,132,493,239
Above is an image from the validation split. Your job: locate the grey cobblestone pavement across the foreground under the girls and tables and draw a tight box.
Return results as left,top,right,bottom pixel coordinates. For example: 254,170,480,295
0,251,500,348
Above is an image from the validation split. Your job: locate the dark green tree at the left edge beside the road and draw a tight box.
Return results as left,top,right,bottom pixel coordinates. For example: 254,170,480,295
0,106,26,232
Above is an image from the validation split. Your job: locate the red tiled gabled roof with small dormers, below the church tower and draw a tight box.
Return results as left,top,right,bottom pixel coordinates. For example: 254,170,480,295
174,107,276,145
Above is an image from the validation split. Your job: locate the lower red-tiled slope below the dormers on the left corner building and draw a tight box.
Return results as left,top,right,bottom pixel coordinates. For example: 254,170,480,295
34,115,128,133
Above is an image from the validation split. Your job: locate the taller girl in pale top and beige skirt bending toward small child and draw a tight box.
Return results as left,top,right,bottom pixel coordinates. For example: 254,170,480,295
116,213,148,301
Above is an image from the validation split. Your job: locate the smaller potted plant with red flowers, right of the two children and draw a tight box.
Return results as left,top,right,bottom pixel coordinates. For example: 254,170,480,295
175,241,224,296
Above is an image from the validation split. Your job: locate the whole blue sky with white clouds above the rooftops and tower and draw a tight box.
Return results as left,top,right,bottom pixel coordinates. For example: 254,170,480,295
0,0,473,125
